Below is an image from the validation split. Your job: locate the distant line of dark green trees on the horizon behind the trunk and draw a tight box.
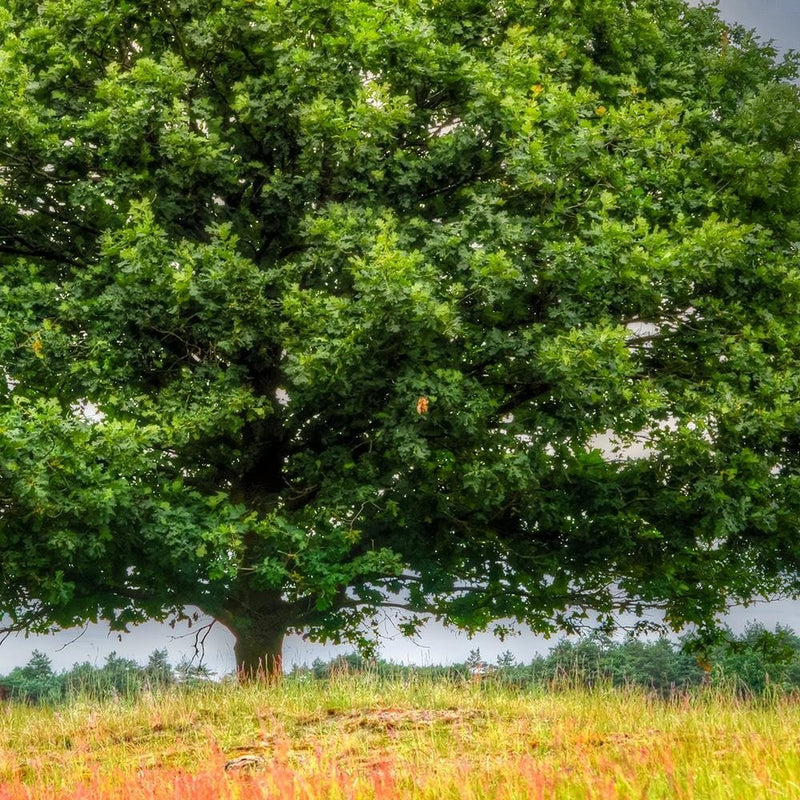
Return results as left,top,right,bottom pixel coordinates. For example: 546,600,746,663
0,624,800,703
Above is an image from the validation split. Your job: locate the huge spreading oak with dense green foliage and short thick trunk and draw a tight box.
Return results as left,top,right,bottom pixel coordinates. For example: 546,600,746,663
0,0,800,671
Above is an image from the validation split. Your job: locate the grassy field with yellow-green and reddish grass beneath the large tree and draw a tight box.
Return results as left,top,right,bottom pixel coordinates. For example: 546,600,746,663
0,676,800,800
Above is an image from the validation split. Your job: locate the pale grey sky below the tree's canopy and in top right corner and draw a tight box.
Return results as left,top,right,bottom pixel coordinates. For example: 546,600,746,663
0,0,800,675
